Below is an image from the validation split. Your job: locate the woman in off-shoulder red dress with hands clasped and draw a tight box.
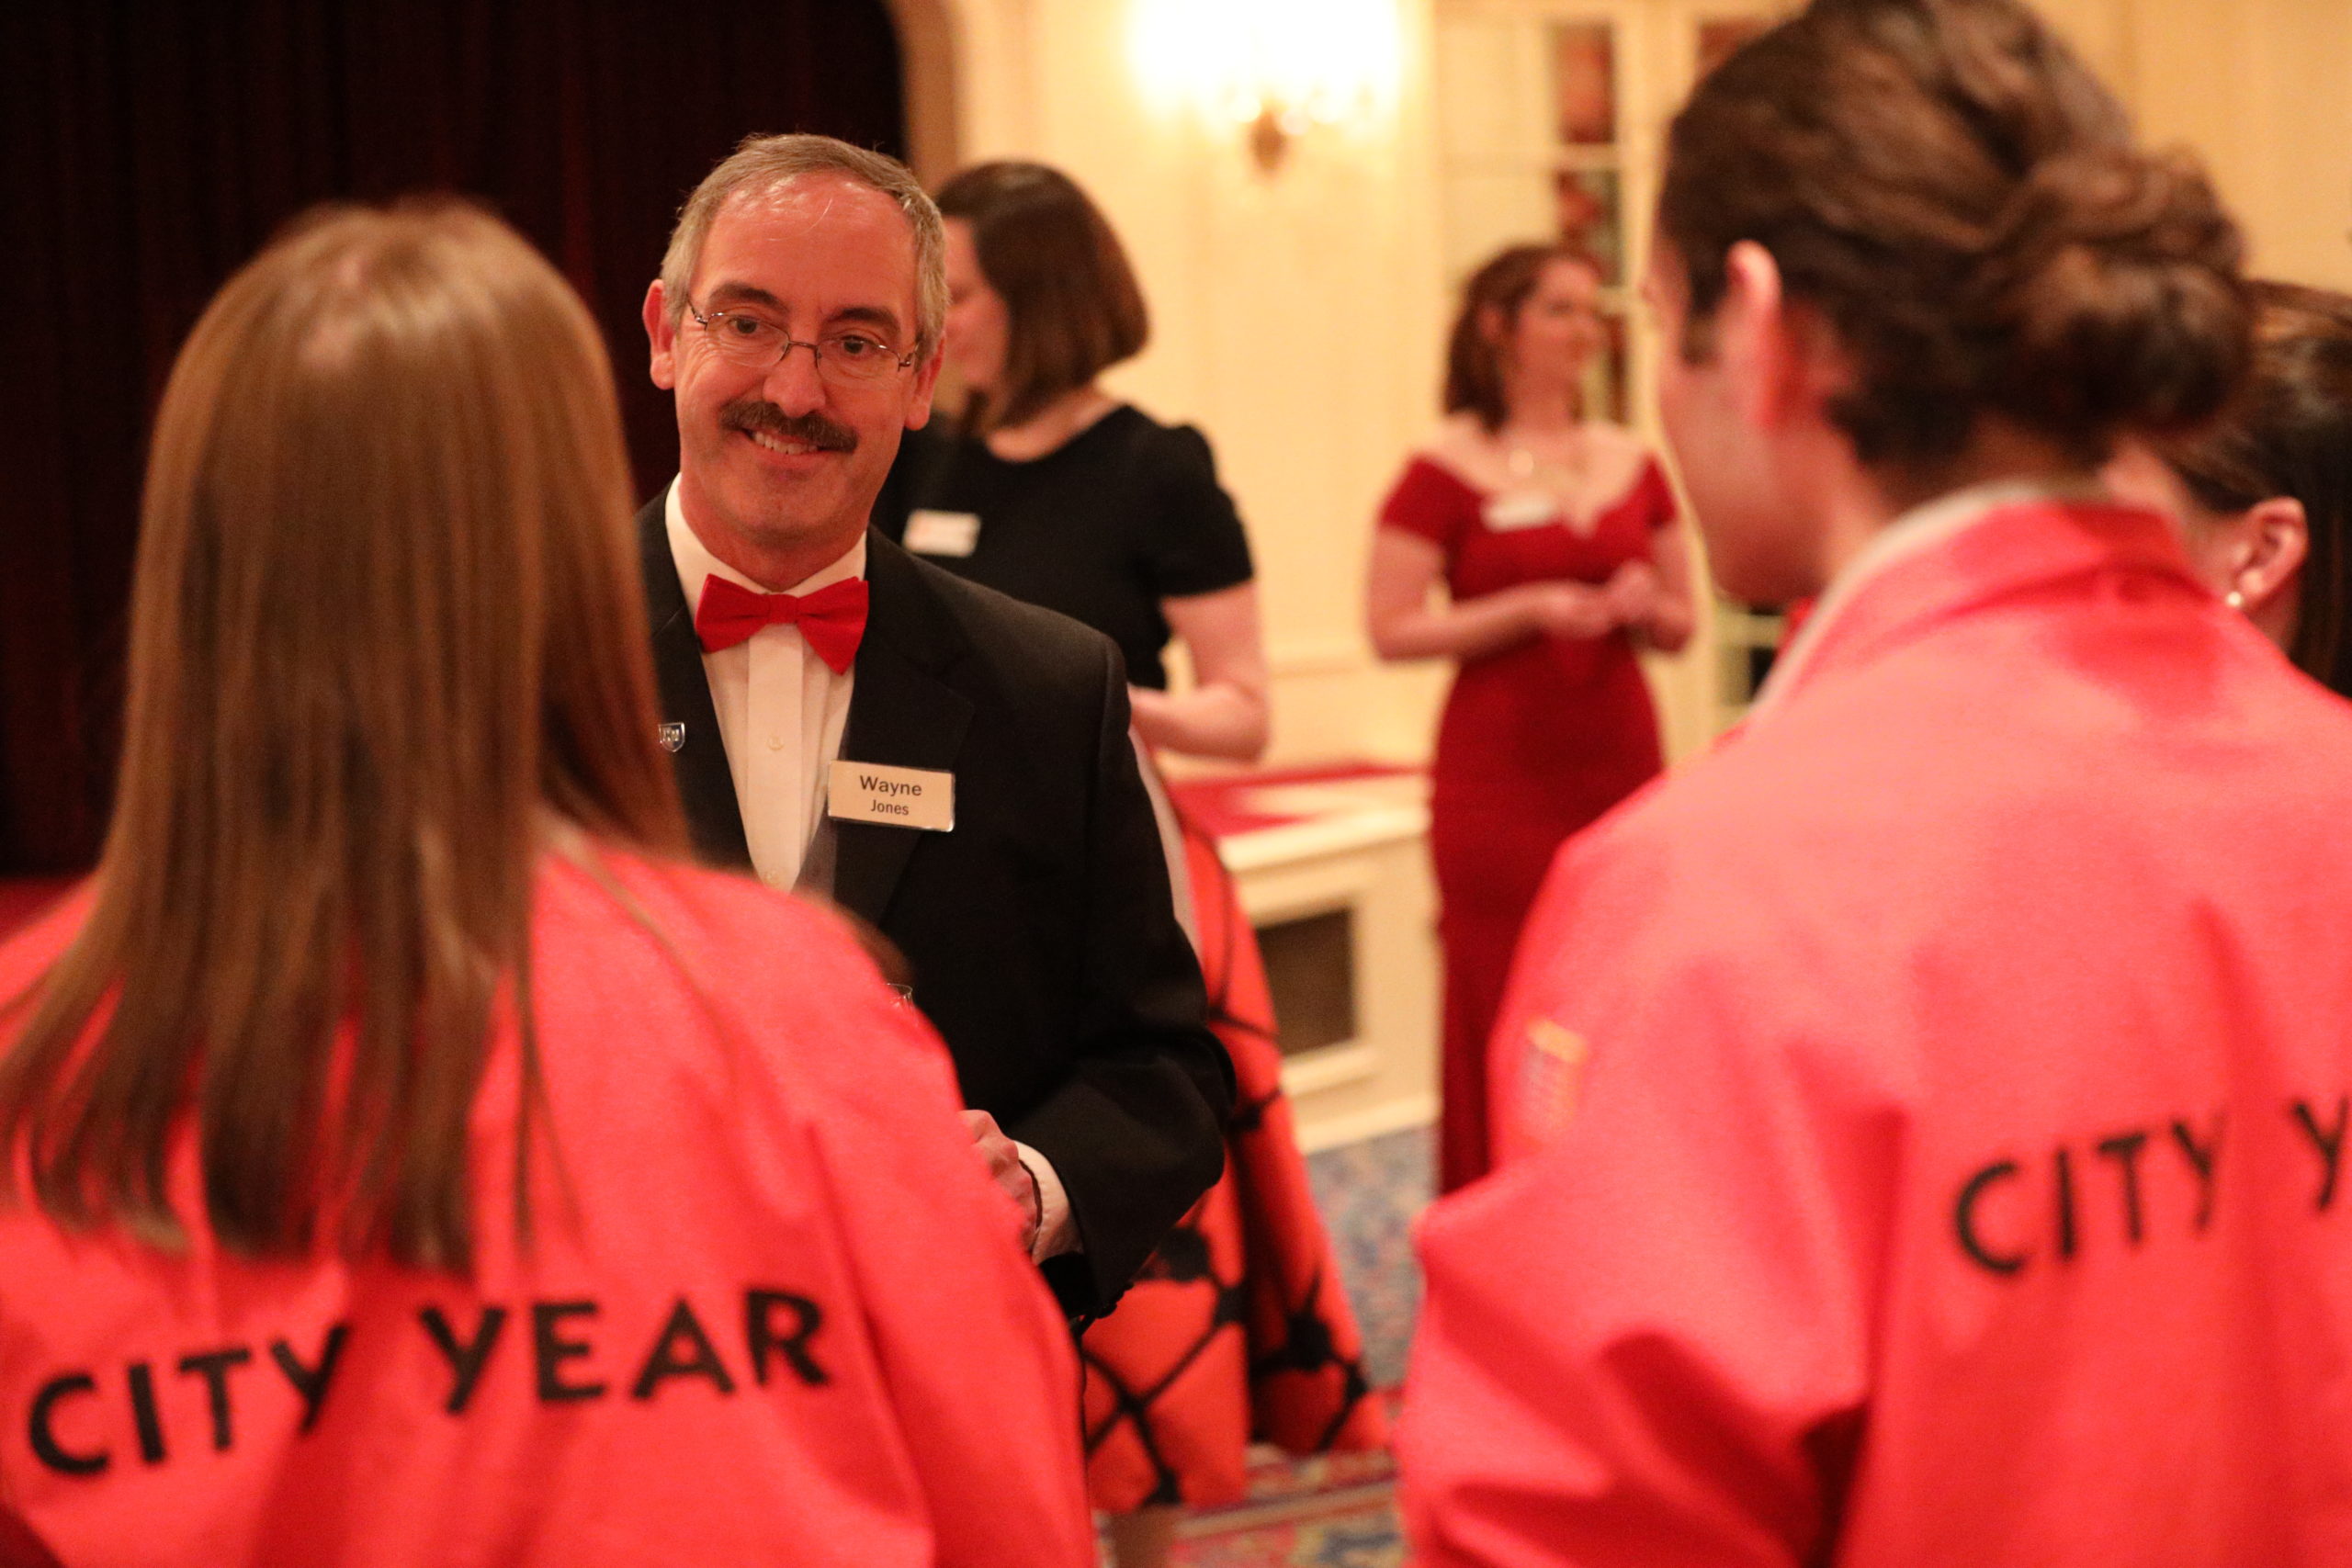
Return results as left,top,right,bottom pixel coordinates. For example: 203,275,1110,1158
1366,244,1691,1192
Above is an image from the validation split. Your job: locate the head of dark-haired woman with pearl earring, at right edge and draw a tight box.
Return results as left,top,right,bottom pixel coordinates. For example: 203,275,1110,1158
2105,282,2352,696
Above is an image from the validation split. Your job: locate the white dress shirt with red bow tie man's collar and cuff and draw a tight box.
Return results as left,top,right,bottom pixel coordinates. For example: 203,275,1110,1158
663,479,1077,1262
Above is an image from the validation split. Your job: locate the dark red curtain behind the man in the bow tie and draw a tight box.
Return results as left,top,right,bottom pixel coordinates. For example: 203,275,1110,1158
0,0,906,874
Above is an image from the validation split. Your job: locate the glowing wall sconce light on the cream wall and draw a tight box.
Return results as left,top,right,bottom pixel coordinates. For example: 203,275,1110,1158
1134,0,1404,174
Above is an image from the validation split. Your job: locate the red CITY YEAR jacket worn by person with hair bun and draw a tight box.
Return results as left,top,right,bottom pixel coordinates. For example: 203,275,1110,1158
1402,501,2352,1568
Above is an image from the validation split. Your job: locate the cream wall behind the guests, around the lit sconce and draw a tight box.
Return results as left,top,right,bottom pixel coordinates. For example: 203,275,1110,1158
896,0,2352,761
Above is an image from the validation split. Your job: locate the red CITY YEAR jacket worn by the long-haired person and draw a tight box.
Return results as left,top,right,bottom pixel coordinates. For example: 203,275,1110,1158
0,853,1093,1568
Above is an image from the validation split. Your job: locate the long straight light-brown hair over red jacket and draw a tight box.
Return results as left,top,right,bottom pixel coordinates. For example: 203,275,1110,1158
0,202,684,1269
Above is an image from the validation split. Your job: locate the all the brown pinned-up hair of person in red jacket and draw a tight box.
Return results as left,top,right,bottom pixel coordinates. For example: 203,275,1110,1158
1658,0,2246,474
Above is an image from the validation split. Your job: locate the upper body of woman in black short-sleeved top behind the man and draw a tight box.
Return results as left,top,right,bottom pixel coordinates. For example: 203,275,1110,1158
875,163,1265,761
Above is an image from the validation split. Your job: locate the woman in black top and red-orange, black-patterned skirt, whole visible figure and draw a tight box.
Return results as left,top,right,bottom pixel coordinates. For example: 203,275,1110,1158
875,163,1385,1568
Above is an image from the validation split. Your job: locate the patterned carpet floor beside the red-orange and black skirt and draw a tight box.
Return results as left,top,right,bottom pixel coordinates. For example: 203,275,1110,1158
1157,1128,1432,1568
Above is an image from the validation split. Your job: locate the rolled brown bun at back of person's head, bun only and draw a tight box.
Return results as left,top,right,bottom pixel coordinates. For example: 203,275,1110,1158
1978,143,2251,445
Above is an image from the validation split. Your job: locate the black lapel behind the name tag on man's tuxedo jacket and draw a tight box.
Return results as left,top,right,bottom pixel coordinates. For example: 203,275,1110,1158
832,531,971,926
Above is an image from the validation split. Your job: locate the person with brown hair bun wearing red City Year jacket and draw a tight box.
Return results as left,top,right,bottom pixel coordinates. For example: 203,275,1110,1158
1399,0,2352,1568
